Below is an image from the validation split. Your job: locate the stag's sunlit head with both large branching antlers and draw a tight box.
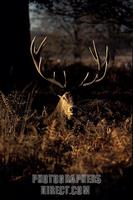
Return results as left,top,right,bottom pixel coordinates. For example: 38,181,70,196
30,37,108,119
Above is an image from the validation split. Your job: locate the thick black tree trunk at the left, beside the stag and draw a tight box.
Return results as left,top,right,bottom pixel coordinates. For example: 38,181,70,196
0,0,33,90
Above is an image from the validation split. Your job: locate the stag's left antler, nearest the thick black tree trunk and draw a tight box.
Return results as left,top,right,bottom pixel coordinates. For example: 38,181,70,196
30,37,66,88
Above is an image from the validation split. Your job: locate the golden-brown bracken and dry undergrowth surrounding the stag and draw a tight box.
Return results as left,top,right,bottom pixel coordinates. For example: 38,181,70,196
0,67,132,181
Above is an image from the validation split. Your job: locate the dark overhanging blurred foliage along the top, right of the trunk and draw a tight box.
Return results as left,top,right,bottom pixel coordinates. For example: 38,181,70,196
29,0,133,28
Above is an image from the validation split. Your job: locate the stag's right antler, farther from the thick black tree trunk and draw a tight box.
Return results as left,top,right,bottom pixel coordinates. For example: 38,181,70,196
79,40,108,86
